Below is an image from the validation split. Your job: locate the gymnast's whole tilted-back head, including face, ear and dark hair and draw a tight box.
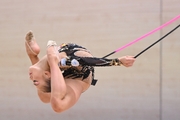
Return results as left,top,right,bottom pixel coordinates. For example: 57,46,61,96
29,65,51,92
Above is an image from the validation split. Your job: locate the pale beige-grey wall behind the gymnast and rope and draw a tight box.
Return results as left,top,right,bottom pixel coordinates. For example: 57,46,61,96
0,0,180,120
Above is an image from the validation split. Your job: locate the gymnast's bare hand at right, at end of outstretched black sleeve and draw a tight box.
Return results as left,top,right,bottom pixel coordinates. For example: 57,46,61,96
118,56,135,67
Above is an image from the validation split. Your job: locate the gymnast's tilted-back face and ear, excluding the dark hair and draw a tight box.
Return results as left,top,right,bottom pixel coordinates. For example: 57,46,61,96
29,65,50,90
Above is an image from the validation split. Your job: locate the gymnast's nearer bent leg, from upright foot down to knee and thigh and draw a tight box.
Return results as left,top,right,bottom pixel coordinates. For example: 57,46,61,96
47,46,83,112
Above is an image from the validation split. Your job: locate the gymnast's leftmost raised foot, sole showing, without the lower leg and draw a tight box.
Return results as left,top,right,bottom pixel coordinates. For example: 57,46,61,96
25,31,40,57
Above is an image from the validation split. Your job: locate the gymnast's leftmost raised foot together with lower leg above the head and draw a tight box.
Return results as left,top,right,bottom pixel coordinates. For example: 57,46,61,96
25,31,40,65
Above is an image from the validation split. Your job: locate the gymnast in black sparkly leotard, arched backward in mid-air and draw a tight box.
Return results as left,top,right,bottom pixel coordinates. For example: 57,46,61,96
25,31,135,113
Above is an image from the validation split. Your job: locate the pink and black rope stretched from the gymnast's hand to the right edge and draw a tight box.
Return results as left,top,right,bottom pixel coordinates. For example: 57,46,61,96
103,15,180,58
